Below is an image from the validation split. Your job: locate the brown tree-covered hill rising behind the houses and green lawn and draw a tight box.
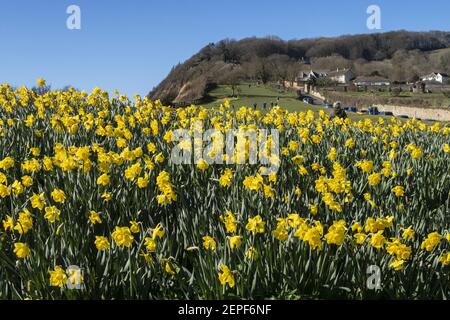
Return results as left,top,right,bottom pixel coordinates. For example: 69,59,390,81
149,31,450,103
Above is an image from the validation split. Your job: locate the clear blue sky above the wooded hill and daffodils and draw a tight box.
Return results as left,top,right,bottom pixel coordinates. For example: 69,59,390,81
0,0,450,95
